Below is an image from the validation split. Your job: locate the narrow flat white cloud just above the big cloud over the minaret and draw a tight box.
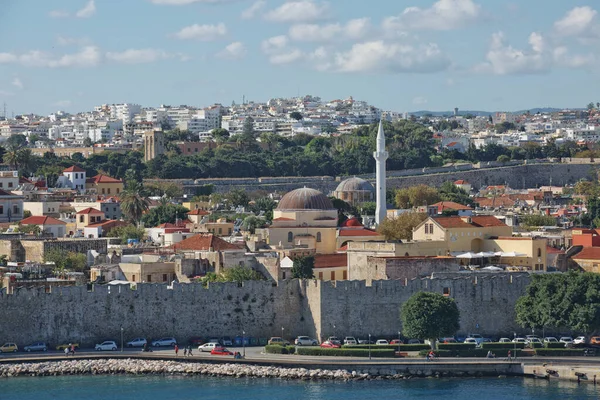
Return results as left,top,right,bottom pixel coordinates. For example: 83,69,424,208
289,18,371,42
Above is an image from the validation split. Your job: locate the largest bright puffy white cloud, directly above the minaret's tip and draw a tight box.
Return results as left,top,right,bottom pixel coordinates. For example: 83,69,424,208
334,40,450,73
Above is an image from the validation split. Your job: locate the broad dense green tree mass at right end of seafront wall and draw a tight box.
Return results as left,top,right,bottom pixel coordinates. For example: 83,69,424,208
515,271,600,334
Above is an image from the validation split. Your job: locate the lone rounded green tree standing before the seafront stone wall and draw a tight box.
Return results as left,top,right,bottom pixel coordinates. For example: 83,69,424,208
400,292,460,343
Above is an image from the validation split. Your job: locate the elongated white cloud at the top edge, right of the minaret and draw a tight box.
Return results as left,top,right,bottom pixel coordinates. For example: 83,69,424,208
383,0,481,32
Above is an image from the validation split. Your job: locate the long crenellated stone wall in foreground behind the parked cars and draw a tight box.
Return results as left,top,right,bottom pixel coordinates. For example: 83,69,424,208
0,274,529,345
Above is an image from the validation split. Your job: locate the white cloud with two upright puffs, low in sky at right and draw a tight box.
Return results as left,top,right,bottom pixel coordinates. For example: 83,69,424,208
475,32,550,75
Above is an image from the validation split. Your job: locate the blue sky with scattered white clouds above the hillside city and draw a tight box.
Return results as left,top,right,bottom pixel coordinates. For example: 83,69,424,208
0,0,600,115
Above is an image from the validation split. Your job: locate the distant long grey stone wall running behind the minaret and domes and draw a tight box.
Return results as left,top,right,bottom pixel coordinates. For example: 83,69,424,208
157,163,598,195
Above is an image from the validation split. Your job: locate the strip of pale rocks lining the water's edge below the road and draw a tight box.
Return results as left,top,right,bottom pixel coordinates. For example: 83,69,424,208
0,359,482,381
